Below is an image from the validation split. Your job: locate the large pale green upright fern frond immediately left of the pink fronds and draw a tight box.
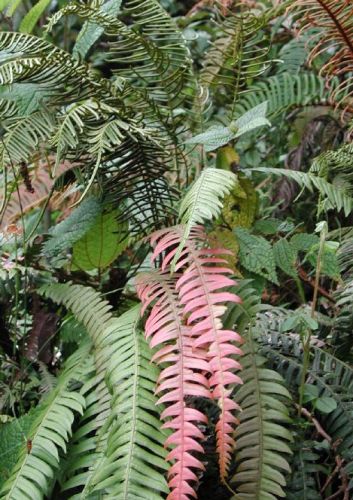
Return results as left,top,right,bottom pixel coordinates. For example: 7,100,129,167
88,306,169,500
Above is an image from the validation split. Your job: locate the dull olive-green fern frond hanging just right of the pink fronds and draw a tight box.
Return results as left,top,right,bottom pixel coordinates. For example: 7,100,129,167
232,336,293,500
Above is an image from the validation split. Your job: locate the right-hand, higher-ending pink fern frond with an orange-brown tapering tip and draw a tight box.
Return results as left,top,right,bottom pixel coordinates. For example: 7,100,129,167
148,226,242,480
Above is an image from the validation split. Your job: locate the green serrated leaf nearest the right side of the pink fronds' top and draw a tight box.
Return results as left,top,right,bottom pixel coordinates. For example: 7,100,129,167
234,228,278,284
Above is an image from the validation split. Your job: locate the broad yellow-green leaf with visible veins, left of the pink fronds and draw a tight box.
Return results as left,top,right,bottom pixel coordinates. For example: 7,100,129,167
72,211,128,271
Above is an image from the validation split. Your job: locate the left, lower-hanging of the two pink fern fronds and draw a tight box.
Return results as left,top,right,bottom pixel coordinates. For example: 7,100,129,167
136,272,211,500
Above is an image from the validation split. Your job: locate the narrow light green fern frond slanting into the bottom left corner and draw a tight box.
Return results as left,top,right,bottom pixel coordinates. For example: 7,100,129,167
0,343,90,500
